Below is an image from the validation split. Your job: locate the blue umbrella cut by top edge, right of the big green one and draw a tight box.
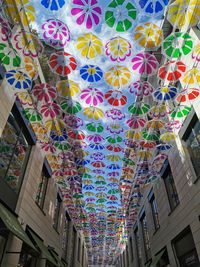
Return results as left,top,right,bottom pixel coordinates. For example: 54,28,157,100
139,0,169,17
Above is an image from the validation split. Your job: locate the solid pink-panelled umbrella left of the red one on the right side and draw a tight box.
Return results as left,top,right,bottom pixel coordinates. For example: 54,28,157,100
132,52,159,77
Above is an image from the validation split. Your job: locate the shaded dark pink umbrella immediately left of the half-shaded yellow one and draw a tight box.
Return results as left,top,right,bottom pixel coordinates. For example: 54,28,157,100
31,83,56,103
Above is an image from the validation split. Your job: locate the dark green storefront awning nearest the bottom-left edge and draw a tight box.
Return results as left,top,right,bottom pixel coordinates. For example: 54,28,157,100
0,203,37,251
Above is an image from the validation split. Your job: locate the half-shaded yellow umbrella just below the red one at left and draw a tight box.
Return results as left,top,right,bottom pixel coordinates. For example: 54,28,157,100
56,80,79,97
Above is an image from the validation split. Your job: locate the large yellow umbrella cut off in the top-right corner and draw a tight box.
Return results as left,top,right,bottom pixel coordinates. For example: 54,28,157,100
167,0,200,30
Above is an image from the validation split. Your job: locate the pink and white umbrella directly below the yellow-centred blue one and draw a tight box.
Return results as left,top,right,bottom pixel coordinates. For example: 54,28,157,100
80,88,104,106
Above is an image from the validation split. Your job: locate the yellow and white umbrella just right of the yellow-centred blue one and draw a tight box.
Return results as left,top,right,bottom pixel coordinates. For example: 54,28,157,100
105,66,131,88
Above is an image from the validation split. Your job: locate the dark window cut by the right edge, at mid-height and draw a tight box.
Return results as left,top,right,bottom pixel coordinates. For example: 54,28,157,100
183,114,200,177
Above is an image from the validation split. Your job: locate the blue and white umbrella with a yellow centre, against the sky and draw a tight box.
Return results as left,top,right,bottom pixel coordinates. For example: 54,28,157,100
80,65,103,82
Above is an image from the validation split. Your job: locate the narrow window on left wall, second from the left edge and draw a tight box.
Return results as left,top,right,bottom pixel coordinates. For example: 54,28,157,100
35,167,50,209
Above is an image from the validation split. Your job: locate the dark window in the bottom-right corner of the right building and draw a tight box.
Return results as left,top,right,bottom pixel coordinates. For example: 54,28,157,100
172,227,200,267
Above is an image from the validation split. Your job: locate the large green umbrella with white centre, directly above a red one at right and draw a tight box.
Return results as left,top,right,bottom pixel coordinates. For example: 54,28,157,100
163,32,193,58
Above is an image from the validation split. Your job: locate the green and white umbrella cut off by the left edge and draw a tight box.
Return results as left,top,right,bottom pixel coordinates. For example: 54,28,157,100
0,43,21,67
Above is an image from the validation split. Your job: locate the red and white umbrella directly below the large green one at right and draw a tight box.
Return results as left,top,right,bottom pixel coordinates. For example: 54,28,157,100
158,60,186,82
